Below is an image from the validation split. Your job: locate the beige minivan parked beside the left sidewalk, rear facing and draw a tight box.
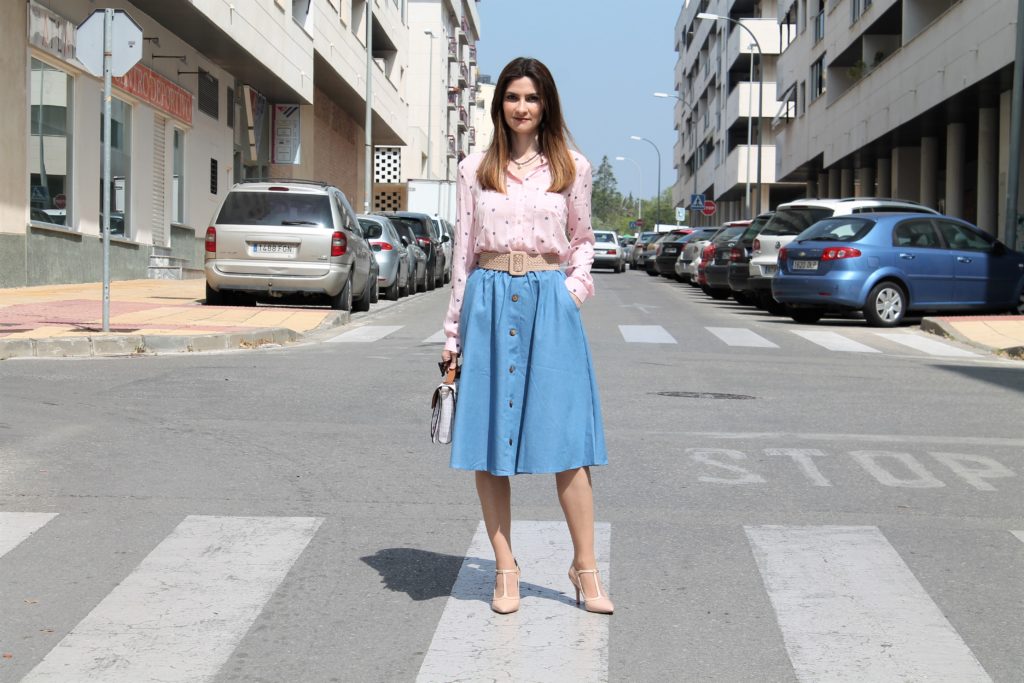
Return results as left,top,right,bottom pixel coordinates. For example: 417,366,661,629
205,180,377,310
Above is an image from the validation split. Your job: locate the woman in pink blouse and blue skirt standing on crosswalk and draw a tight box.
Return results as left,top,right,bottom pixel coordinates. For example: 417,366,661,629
441,57,612,614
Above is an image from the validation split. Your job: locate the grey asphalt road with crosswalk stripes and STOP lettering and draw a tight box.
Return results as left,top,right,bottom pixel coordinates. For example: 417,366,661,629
0,271,1024,682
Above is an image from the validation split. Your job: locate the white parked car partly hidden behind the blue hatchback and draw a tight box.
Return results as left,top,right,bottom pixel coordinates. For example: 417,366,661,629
748,198,938,314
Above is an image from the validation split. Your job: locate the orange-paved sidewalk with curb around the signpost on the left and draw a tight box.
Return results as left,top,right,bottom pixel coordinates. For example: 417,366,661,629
0,280,348,359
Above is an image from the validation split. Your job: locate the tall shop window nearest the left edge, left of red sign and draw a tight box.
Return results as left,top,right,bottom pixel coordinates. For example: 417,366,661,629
29,59,75,225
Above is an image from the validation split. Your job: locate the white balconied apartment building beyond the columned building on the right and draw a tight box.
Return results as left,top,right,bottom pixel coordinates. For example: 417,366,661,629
672,0,804,225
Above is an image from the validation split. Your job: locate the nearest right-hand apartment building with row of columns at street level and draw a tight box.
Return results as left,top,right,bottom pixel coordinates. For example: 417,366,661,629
773,0,1022,240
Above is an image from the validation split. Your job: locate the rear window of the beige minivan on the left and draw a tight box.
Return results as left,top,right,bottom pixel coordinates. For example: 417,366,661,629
217,191,334,228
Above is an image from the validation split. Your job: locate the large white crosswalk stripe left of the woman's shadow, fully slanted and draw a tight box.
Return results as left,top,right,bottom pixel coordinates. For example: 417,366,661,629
23,516,322,683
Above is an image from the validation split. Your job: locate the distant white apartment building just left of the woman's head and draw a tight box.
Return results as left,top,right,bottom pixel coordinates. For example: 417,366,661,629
391,0,480,220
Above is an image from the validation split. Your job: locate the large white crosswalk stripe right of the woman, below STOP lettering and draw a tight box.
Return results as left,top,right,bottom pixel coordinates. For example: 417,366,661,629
745,526,990,683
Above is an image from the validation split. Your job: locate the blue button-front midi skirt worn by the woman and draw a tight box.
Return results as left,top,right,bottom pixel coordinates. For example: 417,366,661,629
452,268,608,476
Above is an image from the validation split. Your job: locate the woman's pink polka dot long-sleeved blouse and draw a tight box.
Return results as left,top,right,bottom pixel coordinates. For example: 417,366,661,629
444,152,594,353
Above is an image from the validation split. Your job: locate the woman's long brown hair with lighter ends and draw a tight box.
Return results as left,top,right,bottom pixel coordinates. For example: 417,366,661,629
476,57,575,193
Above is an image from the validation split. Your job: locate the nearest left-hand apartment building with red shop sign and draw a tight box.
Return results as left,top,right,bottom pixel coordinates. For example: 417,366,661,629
0,0,409,287
